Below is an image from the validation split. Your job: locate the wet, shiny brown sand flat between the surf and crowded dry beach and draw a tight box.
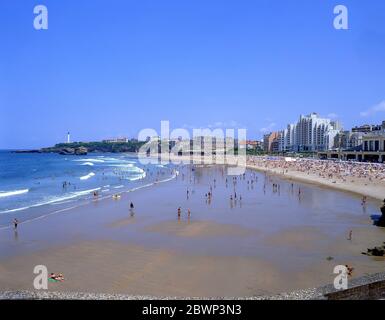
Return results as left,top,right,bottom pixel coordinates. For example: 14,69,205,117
0,166,385,297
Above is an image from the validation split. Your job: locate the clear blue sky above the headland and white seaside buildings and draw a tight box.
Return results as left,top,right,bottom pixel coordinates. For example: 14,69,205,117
0,0,385,149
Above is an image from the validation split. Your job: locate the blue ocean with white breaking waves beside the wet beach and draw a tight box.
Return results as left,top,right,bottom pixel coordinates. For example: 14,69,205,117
0,151,175,228
